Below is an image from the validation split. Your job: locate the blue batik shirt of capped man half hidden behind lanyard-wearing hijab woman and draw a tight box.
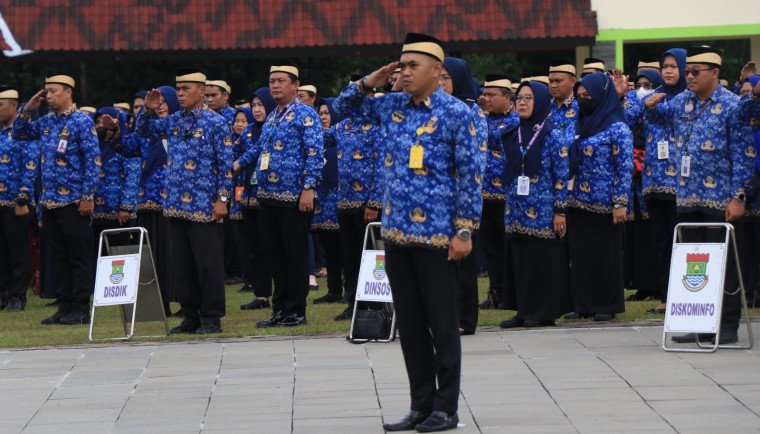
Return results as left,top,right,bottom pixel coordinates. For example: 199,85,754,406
483,111,520,202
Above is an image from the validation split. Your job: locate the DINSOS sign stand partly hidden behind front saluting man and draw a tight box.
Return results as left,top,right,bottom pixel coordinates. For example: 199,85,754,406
348,222,396,344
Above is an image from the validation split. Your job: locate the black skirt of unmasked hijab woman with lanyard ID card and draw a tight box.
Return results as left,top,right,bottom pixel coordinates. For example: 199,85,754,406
507,237,572,321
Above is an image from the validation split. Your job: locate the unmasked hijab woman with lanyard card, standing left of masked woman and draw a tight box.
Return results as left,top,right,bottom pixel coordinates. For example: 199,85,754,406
501,81,570,328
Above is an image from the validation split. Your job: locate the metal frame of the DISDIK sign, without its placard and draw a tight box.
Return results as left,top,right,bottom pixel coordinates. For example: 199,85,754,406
89,227,169,341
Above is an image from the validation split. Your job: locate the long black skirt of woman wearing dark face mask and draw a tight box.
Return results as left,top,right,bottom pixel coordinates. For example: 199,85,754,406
567,208,625,315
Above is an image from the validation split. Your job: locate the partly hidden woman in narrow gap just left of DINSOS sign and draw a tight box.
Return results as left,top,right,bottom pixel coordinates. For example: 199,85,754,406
311,98,344,309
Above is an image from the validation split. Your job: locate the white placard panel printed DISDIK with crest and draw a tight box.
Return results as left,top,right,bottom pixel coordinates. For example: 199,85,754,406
92,254,140,306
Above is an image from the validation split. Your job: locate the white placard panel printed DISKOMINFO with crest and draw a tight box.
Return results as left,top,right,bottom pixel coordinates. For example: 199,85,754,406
665,243,726,333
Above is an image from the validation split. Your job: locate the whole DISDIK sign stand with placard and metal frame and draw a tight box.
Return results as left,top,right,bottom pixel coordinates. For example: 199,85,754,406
89,227,169,341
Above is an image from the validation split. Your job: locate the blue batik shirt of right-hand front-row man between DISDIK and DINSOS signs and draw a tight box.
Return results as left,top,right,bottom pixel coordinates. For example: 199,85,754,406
238,98,324,206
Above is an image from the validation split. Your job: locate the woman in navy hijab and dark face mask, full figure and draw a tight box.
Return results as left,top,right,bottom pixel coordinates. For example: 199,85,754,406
566,73,633,321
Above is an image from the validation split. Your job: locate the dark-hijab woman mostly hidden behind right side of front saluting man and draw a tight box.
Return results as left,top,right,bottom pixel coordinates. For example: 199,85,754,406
441,57,488,335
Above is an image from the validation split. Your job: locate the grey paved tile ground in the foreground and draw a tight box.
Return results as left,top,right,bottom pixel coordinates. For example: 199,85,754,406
0,323,760,434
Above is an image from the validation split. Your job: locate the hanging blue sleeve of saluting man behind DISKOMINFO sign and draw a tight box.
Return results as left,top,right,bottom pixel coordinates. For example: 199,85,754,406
727,105,757,197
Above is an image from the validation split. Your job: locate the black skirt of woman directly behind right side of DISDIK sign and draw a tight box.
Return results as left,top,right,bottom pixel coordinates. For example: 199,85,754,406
137,211,177,303
